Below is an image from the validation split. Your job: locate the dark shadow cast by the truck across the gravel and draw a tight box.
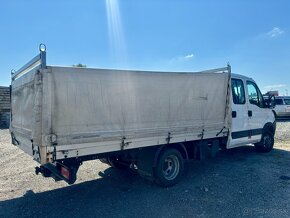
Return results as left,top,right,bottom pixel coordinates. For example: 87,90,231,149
0,147,290,217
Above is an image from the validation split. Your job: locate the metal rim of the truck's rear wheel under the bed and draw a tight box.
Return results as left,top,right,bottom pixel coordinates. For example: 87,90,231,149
162,155,180,180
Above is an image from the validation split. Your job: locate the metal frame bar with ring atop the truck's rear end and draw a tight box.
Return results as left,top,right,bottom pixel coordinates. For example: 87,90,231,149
11,44,46,81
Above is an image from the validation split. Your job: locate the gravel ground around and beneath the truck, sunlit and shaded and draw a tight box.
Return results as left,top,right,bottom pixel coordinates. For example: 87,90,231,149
0,122,290,218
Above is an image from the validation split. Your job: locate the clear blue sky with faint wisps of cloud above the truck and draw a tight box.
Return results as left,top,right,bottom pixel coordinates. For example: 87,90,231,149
0,0,290,95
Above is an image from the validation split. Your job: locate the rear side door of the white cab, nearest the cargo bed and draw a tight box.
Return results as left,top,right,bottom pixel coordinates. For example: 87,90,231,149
227,78,251,148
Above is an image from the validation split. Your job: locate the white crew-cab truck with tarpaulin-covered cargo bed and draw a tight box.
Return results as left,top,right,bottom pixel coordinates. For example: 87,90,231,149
10,47,276,186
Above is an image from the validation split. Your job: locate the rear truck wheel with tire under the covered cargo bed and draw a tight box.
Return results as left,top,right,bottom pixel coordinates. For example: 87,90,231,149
154,148,184,187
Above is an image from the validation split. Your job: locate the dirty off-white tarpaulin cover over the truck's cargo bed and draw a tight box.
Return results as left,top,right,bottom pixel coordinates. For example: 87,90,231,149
12,67,229,164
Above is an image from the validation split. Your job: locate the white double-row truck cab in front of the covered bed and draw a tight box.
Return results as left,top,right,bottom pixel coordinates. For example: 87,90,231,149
227,74,276,152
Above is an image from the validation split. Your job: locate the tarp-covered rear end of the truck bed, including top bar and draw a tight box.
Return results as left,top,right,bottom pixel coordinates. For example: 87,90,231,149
10,46,45,162
